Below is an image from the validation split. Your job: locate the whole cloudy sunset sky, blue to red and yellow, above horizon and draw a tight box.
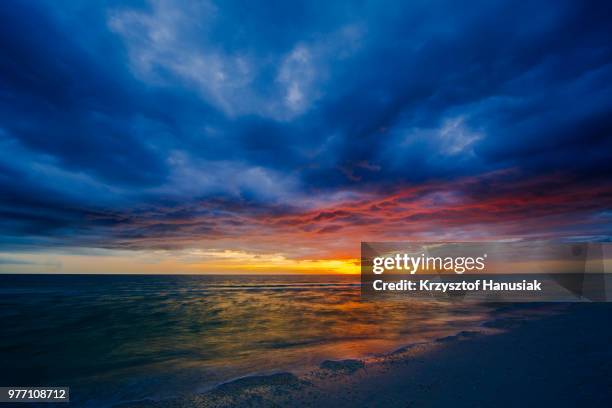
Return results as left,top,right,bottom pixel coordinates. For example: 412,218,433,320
0,0,612,273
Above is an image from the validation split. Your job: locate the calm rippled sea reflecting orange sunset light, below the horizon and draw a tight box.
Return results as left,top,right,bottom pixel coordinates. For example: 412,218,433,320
0,275,516,407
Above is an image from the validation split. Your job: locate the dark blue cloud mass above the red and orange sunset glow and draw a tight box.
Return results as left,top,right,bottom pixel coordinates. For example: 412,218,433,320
0,0,612,249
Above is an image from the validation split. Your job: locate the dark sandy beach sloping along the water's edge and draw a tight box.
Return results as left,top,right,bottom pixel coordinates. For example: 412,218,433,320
122,304,612,408
